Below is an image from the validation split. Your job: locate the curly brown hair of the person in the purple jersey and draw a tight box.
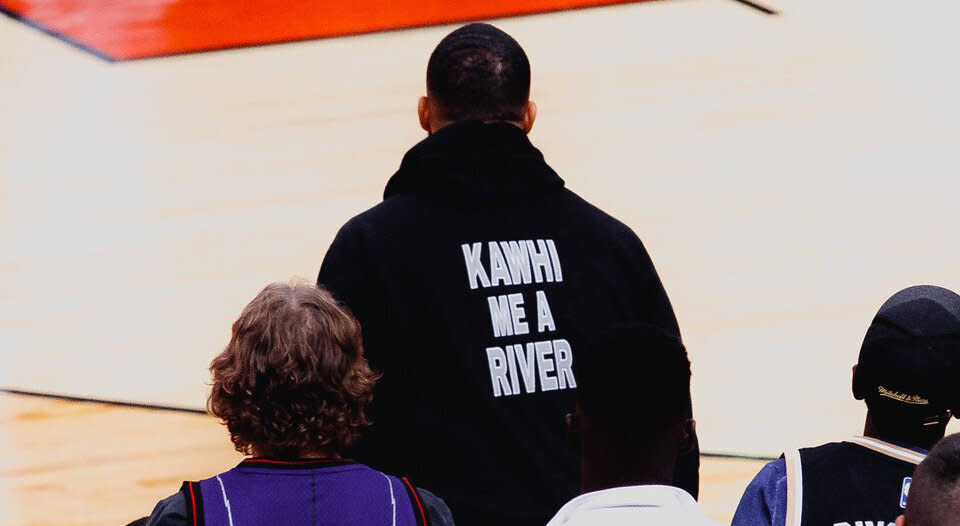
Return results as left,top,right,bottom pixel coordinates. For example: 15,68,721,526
207,283,379,458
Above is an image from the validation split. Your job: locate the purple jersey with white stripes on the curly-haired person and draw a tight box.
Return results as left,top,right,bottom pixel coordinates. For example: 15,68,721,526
182,458,426,526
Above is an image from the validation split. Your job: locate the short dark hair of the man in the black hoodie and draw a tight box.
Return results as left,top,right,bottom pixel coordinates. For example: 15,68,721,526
427,24,530,121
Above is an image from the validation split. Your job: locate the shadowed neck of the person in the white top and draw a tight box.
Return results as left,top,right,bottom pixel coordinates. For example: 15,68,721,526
576,412,694,493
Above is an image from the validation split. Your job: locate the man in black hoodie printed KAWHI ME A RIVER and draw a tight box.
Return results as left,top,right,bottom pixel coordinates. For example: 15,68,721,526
318,24,699,526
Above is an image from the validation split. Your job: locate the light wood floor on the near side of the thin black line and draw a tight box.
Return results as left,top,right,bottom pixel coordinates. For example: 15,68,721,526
0,394,762,526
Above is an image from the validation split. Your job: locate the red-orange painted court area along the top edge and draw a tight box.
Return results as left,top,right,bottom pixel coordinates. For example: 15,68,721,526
0,0,652,60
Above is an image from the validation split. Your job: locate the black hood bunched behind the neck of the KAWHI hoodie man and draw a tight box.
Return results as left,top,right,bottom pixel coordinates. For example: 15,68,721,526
383,121,564,203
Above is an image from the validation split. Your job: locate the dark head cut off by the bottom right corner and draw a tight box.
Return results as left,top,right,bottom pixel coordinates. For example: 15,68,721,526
897,434,960,526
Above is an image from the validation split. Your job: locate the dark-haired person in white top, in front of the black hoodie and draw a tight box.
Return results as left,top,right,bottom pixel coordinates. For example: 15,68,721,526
550,324,706,526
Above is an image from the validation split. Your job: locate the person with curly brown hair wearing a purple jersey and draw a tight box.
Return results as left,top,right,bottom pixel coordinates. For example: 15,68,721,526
137,283,453,526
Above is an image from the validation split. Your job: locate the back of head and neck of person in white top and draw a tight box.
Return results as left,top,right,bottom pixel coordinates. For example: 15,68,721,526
573,324,694,492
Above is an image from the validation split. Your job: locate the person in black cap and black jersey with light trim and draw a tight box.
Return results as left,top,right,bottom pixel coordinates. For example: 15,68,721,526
733,286,960,526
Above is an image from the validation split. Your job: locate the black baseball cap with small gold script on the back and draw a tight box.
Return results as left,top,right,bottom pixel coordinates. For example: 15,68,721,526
854,285,960,424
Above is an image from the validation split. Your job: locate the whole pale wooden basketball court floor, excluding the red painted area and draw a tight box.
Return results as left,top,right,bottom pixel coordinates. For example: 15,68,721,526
0,0,960,525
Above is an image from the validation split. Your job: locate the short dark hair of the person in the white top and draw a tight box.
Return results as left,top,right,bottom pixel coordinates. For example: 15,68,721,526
574,323,690,426
